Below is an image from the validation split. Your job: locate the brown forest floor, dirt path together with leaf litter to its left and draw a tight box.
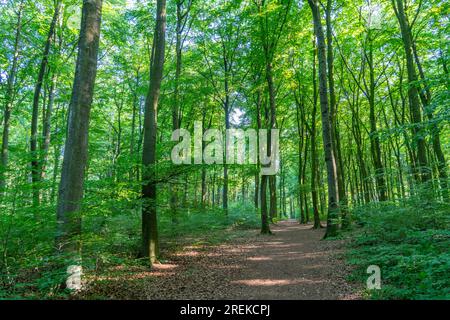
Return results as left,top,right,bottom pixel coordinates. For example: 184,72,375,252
83,220,359,300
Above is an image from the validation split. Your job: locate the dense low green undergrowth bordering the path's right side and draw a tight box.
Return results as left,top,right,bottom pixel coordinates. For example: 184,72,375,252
347,197,450,299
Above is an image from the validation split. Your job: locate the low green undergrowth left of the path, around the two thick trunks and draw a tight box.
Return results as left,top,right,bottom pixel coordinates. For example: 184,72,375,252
0,176,259,299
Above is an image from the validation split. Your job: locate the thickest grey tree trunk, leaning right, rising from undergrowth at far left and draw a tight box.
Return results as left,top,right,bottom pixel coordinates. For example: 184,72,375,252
56,0,102,289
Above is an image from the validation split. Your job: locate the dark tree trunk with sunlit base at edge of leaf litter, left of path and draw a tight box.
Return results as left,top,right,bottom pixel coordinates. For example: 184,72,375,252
142,0,166,264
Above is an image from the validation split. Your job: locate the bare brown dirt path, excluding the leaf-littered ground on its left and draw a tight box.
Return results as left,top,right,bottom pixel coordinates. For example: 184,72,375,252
227,220,360,300
